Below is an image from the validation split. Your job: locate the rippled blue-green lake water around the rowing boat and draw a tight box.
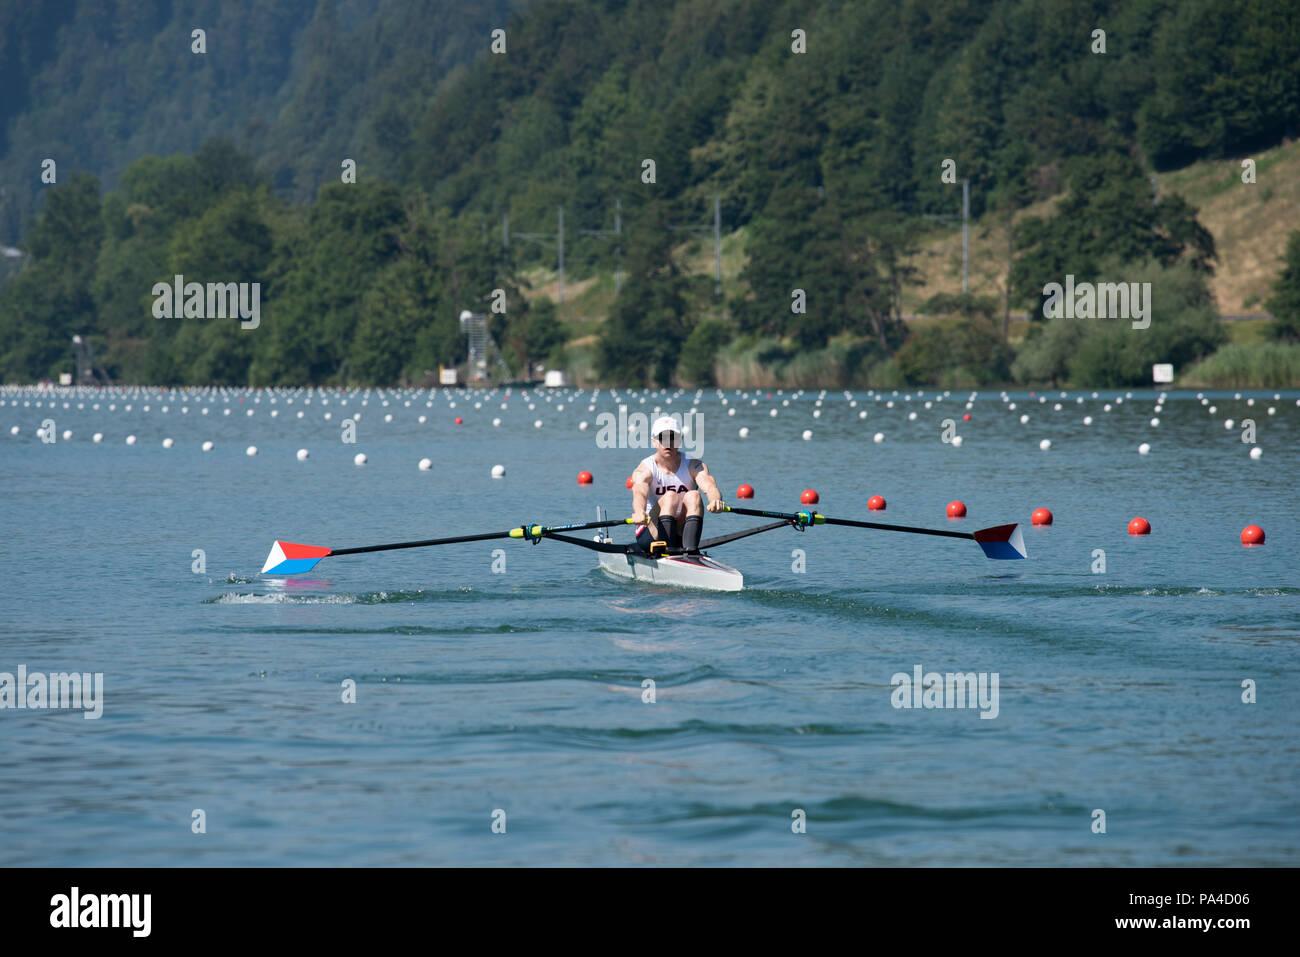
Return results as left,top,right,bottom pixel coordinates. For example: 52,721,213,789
0,389,1300,866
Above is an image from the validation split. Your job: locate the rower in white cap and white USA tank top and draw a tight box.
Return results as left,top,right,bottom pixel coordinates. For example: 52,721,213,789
632,416,727,555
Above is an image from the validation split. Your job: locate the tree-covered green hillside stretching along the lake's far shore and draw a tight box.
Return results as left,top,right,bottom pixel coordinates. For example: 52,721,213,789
0,0,1300,384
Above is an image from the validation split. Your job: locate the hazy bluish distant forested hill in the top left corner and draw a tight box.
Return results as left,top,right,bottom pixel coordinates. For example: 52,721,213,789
0,0,520,242
